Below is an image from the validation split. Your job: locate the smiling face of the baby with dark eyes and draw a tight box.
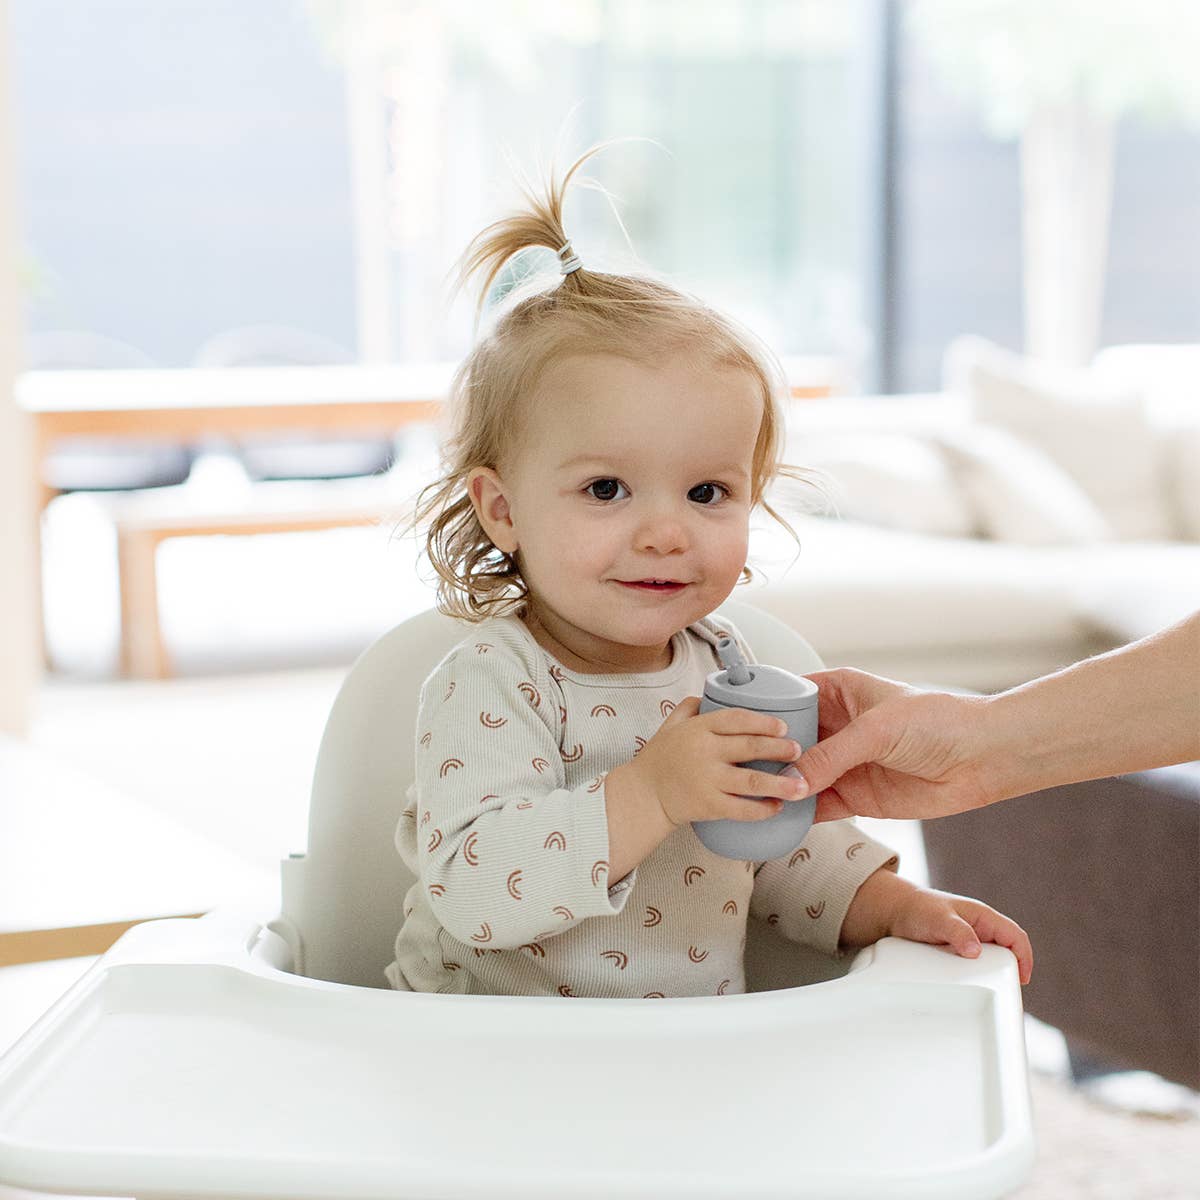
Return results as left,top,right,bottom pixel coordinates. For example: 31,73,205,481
477,355,763,671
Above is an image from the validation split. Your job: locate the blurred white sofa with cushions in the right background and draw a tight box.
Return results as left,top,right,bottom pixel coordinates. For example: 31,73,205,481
743,338,1200,691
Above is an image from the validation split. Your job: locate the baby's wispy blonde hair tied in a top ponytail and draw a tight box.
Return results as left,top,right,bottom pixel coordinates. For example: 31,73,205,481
409,144,809,622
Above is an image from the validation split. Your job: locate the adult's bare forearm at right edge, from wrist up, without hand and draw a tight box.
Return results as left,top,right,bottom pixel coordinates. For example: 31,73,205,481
978,613,1200,799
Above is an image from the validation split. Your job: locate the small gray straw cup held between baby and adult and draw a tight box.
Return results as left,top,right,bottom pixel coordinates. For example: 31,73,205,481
691,637,817,862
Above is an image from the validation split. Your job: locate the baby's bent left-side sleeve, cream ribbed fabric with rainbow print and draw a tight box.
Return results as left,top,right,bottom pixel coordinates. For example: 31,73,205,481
412,646,631,949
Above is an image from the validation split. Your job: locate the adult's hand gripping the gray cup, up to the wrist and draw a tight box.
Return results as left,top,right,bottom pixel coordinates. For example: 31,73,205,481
796,668,1000,821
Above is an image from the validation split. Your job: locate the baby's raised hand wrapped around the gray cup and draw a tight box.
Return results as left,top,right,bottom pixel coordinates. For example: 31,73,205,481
610,696,803,826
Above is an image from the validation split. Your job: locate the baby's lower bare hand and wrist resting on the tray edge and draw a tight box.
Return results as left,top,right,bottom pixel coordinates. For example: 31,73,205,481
841,871,1033,983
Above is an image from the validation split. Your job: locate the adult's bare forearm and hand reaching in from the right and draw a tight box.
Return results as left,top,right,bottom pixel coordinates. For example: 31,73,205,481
796,612,1200,821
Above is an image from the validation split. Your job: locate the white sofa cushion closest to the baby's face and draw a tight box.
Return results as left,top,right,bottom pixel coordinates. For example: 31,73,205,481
797,433,976,538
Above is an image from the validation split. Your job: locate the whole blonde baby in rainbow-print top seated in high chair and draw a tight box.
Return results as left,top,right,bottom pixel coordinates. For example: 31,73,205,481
386,151,1032,997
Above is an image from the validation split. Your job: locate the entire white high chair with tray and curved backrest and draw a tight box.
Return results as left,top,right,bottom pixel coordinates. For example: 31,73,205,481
0,602,1033,1200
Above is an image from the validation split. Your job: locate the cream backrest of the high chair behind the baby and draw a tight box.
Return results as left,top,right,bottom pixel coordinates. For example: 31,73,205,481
272,601,840,988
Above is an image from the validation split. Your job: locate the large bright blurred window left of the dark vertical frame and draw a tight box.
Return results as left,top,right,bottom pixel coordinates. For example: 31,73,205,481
11,0,869,366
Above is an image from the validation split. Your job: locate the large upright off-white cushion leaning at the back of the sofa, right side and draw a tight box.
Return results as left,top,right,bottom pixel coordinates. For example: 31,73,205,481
943,337,1174,540
